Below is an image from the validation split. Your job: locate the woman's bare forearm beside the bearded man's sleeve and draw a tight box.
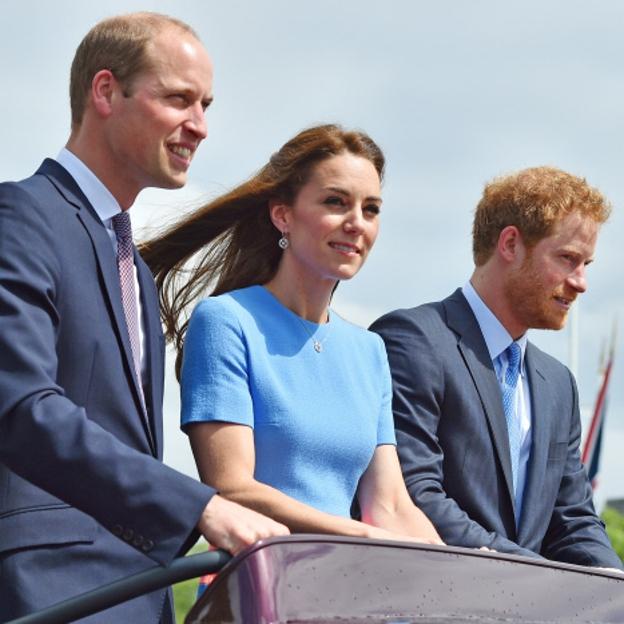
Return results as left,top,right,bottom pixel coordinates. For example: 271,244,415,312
358,444,444,544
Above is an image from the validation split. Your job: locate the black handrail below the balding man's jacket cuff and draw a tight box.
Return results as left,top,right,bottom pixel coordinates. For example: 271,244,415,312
7,550,231,624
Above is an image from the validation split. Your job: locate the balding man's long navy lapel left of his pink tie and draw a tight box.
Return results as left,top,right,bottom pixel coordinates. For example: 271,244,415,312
38,159,155,451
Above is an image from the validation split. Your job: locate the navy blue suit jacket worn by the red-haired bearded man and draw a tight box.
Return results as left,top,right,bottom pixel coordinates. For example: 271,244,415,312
371,290,622,567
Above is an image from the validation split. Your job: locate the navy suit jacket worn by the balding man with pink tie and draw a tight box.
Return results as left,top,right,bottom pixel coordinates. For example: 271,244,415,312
0,160,214,623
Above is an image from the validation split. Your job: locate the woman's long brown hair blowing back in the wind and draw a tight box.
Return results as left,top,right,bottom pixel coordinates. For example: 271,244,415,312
139,125,385,378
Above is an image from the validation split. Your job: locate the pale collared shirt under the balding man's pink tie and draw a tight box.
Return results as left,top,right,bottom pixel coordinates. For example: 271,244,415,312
56,147,146,383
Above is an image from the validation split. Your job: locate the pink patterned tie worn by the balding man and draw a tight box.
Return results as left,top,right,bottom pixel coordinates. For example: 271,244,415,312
113,212,145,409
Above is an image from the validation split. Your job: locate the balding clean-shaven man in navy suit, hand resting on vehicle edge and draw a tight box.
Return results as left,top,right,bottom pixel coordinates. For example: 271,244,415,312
0,13,287,623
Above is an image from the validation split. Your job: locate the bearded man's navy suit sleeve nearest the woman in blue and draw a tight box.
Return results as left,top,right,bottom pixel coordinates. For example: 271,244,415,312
370,311,538,558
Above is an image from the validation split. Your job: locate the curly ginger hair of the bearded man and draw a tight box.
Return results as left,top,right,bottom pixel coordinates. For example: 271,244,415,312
472,167,611,266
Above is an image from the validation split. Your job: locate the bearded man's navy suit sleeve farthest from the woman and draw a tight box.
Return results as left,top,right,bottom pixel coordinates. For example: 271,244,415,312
542,371,622,569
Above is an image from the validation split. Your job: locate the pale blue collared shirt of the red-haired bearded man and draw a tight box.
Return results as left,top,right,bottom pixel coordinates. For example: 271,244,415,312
462,282,532,526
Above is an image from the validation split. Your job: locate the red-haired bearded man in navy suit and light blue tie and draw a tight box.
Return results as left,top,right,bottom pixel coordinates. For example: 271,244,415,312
371,167,622,568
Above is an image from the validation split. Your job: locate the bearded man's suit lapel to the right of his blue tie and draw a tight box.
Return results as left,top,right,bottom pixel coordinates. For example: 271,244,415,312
518,342,551,543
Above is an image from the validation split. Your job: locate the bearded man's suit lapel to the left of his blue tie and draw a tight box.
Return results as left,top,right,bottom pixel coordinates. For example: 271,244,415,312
444,289,515,510
